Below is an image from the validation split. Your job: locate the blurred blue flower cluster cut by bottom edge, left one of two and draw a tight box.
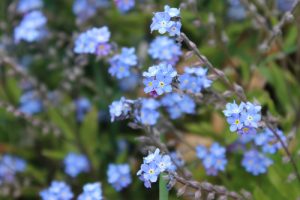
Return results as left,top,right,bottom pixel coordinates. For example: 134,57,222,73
40,181,74,200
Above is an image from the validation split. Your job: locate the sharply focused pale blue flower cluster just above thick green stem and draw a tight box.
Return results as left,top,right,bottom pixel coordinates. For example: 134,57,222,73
137,149,173,188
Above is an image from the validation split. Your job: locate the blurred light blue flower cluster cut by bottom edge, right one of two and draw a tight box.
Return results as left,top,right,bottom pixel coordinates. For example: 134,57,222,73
78,183,103,200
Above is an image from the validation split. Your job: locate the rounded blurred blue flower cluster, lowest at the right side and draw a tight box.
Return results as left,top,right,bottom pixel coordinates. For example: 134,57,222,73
242,149,273,176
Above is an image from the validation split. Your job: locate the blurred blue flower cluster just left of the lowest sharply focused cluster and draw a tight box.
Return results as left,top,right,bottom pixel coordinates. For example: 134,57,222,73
107,164,132,191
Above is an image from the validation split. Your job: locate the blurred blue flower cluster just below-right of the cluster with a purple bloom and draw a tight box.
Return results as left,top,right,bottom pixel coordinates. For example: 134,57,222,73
108,47,137,79
